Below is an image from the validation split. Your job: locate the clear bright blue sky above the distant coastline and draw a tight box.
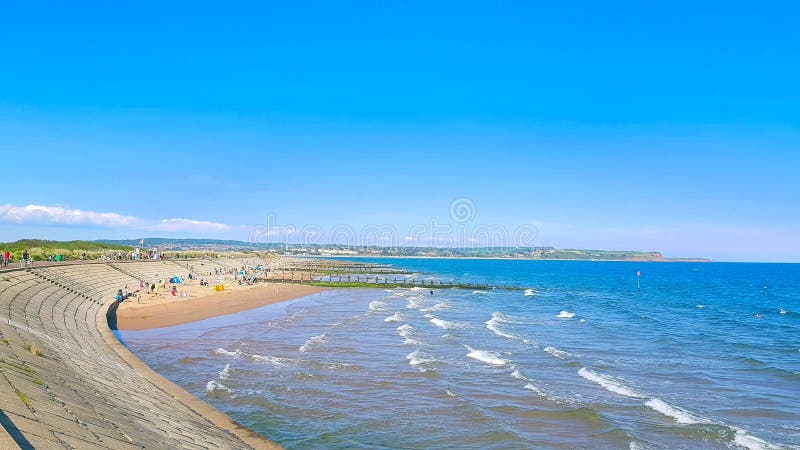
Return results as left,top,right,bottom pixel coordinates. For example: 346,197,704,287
0,2,800,261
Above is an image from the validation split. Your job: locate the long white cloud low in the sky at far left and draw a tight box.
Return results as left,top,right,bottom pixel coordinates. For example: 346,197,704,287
0,205,136,227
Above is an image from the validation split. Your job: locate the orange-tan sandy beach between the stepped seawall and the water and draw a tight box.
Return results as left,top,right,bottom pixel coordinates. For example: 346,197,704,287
117,280,324,331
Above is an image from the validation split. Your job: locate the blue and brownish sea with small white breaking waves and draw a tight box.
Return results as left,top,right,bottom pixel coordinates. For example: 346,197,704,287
121,259,800,449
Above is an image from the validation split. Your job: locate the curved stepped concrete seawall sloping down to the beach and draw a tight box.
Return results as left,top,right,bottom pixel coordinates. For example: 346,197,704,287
0,262,277,449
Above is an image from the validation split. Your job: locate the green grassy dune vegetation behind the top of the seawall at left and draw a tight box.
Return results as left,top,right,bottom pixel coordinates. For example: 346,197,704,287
0,239,133,261
